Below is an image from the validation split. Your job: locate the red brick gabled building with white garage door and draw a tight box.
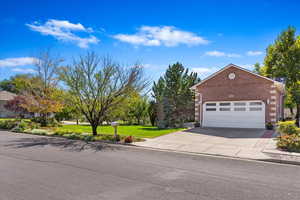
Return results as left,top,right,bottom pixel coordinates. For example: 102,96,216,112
191,64,284,128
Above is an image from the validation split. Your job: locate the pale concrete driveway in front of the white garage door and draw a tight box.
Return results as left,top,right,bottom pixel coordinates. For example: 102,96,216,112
135,128,275,159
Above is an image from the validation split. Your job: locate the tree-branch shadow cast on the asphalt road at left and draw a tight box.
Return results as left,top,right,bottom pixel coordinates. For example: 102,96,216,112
3,136,119,152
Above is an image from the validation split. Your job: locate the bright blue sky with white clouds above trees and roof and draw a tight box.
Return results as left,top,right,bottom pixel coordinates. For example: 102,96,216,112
0,0,300,80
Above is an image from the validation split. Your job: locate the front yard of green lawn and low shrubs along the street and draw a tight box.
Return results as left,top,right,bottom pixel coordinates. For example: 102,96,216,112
0,119,183,143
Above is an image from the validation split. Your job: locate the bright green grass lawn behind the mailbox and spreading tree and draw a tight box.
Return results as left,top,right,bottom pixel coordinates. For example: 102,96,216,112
58,125,184,138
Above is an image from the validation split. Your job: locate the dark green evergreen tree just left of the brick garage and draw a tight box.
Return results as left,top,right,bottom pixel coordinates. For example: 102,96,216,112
153,63,200,127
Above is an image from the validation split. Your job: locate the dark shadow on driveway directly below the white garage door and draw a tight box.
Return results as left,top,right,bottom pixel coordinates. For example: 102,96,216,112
182,127,265,139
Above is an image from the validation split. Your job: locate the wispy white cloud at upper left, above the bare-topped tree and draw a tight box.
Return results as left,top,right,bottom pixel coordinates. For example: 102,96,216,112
26,19,100,48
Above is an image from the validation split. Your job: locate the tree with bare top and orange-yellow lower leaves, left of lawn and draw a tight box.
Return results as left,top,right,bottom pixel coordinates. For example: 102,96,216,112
23,50,63,125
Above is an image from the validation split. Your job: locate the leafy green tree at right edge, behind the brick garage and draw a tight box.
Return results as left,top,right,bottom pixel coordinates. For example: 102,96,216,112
264,27,300,125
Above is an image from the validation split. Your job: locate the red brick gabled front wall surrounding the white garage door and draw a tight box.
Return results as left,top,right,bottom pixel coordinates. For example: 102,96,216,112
195,67,280,122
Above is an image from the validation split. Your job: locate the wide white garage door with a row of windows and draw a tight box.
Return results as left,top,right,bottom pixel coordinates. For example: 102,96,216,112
203,101,265,128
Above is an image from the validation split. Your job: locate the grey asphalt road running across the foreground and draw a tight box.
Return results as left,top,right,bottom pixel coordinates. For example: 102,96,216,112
0,131,300,200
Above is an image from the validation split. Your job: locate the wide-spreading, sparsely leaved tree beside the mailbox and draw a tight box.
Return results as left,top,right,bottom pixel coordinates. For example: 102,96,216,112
61,52,146,135
